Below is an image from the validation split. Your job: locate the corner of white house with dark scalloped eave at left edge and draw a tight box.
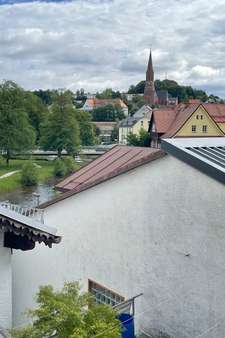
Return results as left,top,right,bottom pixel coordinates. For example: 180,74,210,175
0,202,60,337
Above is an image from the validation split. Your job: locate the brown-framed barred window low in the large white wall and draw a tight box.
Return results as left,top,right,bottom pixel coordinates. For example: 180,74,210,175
88,279,125,306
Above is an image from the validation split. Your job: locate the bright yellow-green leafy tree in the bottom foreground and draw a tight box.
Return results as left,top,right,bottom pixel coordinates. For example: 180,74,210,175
12,283,121,338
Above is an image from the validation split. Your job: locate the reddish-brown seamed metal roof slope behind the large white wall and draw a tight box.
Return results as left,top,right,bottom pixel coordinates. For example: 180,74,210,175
40,146,164,208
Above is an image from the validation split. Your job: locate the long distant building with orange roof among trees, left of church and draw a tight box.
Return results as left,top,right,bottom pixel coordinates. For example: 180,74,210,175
82,98,128,116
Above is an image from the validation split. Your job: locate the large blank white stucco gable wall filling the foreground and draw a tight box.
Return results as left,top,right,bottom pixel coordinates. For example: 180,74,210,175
13,156,225,338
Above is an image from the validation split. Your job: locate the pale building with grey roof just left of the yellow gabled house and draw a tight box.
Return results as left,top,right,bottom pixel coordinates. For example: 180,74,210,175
119,105,152,144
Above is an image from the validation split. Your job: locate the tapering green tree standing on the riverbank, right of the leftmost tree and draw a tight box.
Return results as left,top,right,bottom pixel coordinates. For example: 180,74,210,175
40,92,80,157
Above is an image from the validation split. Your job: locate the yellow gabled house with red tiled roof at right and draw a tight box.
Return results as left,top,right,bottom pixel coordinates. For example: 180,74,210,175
149,100,225,148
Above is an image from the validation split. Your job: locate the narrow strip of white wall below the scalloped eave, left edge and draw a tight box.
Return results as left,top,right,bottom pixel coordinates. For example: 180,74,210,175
0,230,12,328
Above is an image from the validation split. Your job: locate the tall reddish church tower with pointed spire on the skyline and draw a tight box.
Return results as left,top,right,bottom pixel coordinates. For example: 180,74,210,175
144,50,157,105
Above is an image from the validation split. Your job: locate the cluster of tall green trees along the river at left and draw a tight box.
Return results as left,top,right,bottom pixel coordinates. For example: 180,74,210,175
0,81,97,163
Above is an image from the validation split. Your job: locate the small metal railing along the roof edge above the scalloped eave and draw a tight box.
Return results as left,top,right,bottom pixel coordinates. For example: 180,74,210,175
0,201,44,224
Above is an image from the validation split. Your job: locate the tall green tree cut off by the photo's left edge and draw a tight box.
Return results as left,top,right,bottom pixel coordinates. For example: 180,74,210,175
0,81,35,164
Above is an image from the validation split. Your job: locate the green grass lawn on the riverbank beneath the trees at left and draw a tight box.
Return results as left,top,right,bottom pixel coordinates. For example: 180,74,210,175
0,159,54,192
